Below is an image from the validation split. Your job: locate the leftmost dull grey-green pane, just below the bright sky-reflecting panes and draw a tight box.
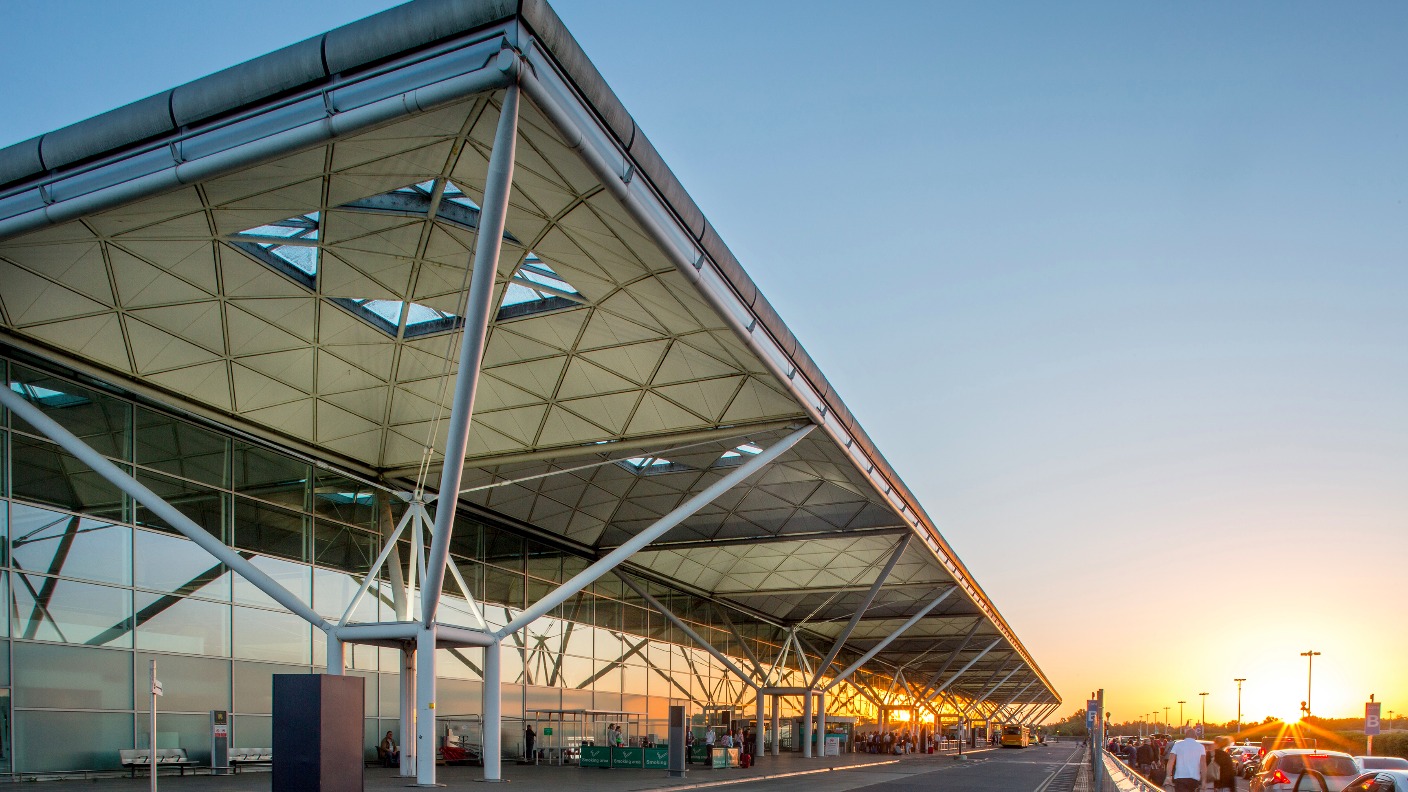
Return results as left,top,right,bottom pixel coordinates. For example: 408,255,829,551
14,641,132,704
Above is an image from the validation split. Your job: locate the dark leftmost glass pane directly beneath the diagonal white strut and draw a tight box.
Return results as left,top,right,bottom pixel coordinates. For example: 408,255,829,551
10,434,122,521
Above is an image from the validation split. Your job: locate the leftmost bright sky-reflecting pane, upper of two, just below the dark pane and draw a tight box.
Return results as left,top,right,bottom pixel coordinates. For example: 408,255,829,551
10,503,132,585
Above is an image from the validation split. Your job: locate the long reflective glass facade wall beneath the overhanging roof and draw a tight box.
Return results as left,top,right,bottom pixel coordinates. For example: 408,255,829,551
0,359,874,772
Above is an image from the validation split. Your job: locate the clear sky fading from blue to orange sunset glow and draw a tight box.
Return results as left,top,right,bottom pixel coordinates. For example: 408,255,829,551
0,0,1408,722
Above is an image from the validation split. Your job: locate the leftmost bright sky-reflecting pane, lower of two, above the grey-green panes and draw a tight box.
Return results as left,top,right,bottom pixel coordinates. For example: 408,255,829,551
11,572,132,647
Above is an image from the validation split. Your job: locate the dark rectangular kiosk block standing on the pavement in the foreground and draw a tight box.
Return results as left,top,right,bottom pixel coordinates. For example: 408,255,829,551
273,674,365,792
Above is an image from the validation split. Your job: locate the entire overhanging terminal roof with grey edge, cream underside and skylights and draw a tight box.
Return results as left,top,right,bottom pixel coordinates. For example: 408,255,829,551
0,0,1059,777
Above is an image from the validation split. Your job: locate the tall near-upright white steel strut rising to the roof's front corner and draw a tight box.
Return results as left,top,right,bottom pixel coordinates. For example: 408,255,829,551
421,83,518,627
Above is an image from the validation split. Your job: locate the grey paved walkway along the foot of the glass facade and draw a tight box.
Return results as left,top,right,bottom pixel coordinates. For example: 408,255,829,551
8,750,990,792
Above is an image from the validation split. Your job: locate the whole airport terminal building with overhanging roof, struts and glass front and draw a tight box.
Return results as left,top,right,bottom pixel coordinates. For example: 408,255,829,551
0,0,1060,782
